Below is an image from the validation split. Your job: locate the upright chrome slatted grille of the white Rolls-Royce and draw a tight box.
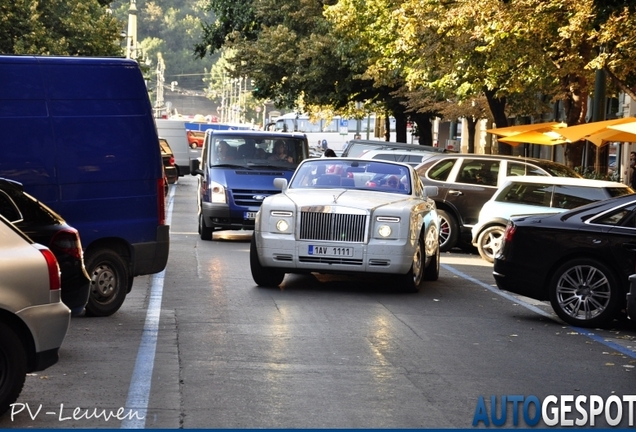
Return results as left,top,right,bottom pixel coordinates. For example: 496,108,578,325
300,211,367,243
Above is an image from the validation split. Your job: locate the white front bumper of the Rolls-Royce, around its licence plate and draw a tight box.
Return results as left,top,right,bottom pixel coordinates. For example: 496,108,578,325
255,232,416,274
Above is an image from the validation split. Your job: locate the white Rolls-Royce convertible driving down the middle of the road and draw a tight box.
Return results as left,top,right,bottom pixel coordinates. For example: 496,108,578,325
250,158,440,291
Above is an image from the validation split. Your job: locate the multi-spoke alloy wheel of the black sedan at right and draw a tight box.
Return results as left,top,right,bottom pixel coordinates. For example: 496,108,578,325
550,258,620,327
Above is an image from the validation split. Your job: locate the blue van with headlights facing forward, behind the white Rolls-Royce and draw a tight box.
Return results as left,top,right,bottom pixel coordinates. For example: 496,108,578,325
190,129,309,240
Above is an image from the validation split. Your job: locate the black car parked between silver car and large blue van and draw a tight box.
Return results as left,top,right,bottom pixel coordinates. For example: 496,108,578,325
0,178,91,315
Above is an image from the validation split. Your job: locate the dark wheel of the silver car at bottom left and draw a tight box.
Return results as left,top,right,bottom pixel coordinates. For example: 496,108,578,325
0,323,27,415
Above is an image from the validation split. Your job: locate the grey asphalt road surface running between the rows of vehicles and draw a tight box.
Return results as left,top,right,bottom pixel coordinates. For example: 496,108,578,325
0,177,636,428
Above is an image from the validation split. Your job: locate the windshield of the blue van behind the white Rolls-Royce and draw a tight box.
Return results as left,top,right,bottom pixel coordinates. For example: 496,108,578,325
208,135,307,168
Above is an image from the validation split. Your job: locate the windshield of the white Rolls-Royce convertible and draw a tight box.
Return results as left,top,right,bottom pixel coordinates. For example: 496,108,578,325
290,158,412,194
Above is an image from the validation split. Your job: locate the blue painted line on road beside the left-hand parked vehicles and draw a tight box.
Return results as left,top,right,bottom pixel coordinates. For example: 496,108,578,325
120,185,175,429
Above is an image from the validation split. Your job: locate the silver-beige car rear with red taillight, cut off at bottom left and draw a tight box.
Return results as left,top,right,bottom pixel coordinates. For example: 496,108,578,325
0,216,71,415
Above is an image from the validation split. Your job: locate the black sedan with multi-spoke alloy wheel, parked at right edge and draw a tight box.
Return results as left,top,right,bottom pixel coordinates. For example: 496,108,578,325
493,194,636,327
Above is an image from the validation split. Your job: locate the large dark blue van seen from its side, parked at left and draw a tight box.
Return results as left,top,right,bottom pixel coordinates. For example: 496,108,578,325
0,56,169,316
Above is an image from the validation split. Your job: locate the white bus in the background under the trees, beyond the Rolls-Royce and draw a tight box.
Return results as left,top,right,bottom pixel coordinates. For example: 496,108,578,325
270,113,402,152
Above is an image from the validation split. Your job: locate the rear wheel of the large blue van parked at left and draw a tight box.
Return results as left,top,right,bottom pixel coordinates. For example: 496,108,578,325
85,249,129,316
